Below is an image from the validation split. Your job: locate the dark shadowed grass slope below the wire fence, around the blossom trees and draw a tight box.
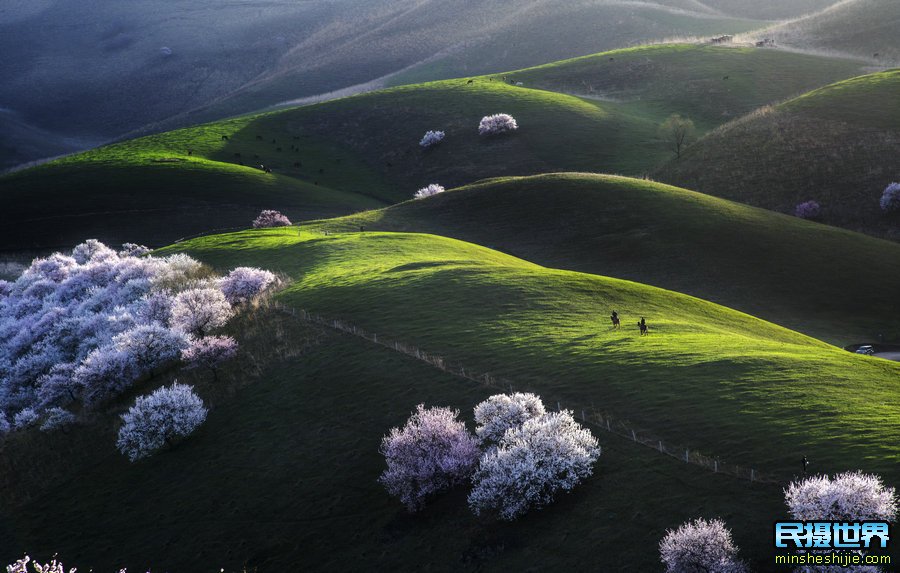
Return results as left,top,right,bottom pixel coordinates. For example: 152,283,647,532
0,302,784,573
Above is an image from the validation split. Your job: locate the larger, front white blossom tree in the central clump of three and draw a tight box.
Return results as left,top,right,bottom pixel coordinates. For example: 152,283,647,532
469,411,600,520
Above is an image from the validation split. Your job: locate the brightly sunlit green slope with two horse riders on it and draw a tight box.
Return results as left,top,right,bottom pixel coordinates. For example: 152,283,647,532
160,229,900,479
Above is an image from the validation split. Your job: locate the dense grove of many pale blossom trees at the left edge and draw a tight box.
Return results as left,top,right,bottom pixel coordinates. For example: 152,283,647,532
0,240,274,430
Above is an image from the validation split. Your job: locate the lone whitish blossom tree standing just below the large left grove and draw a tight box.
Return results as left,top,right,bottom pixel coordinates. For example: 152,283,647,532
116,383,207,462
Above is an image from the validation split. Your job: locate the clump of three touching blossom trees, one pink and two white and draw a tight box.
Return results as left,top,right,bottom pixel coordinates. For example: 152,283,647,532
380,394,600,519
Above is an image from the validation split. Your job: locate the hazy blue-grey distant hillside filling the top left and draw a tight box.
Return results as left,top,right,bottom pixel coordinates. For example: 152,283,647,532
0,0,763,169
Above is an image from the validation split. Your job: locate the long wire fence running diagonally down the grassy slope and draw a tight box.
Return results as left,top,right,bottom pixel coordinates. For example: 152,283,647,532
264,299,789,485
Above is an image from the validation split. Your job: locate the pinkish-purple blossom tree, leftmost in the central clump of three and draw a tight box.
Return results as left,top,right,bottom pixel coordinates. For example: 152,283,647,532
379,404,480,511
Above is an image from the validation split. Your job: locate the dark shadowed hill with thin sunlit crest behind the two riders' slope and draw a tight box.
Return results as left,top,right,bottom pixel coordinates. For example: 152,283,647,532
298,174,900,346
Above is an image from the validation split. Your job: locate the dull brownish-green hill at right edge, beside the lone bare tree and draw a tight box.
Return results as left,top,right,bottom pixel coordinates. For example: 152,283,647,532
657,70,900,239
